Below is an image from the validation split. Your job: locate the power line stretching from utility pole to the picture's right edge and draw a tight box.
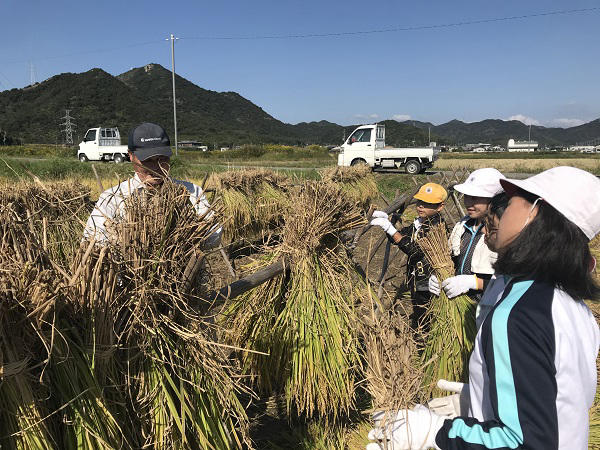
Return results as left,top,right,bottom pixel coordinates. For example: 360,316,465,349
181,7,600,40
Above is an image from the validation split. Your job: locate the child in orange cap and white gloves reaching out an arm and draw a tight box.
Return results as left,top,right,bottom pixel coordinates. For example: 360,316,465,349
371,183,448,329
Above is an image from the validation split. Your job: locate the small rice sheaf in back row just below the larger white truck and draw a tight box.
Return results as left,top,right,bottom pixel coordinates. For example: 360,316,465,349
320,164,379,209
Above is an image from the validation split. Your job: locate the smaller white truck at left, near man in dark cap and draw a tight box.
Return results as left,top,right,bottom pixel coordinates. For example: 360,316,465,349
77,128,129,163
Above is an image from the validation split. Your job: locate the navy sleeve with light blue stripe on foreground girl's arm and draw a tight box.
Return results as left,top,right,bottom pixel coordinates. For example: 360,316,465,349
436,281,559,450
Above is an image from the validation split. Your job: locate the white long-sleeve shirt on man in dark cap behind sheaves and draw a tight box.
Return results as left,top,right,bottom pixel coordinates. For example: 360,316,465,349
83,174,222,248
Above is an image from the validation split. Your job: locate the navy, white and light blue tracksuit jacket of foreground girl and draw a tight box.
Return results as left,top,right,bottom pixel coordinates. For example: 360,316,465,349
436,276,600,450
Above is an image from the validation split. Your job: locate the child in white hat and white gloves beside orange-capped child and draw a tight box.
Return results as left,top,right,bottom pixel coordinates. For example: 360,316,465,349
429,168,505,301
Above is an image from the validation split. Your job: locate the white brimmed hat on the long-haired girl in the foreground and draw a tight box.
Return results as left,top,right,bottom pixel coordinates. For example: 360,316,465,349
500,166,600,240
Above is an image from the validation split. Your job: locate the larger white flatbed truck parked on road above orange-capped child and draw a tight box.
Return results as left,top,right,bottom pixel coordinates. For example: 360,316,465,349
338,123,440,174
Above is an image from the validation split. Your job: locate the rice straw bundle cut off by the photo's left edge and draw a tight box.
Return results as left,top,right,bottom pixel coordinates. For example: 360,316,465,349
0,205,56,448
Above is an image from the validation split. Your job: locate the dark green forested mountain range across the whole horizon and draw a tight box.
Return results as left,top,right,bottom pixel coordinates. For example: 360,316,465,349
0,64,600,147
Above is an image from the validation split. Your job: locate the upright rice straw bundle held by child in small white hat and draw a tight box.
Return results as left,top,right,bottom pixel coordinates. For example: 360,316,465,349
417,224,477,395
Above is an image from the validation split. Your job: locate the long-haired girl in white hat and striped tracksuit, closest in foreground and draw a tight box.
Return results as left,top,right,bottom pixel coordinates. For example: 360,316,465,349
367,167,600,450
